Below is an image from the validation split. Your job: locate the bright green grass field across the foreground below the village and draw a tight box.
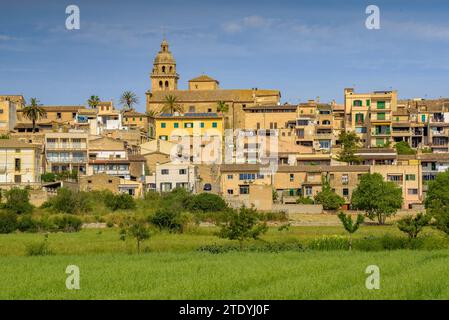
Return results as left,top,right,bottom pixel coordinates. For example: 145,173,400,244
0,226,449,299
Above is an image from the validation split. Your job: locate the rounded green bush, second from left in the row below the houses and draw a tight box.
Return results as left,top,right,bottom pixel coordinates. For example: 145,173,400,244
48,188,92,214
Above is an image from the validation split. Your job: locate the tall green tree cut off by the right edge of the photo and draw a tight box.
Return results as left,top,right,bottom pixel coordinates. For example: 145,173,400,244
425,171,449,235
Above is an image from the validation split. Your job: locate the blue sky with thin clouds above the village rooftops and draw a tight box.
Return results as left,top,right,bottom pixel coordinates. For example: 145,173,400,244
0,0,449,110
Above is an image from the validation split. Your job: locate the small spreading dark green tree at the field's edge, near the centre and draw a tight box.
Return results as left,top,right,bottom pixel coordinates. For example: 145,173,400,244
218,207,268,250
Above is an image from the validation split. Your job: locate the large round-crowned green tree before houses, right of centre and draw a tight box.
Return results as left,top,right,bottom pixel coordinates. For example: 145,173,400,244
351,173,403,224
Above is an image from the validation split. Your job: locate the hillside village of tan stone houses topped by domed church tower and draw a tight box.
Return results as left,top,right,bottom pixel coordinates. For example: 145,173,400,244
0,40,449,210
